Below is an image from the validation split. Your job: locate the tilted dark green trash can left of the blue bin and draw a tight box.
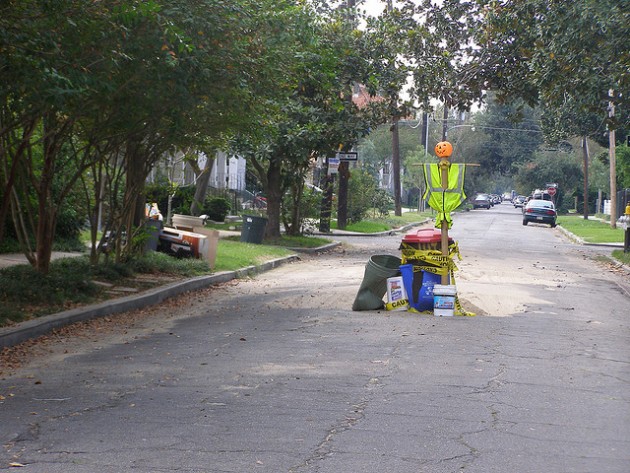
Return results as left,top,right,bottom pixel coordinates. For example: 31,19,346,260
352,255,400,310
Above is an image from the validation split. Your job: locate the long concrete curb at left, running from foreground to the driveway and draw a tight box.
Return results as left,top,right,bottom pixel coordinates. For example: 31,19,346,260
0,255,300,349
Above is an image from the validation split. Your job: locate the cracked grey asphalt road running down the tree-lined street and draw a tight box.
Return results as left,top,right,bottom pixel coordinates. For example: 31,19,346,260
0,204,630,473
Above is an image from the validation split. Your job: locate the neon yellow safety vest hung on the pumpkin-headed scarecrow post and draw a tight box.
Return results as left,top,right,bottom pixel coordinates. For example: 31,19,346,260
422,163,466,228
